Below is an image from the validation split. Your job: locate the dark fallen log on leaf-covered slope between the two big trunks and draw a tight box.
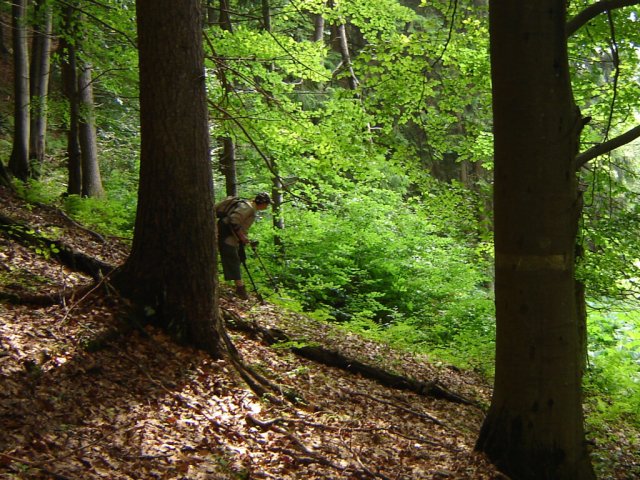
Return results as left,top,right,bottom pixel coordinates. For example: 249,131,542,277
224,310,476,405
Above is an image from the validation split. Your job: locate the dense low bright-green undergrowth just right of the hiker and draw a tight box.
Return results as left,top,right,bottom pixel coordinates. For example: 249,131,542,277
250,181,494,371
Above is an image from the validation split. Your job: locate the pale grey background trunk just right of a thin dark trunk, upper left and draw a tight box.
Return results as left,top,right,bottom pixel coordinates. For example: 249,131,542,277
77,64,104,197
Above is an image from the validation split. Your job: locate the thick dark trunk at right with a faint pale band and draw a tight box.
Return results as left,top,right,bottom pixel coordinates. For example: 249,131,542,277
476,0,595,480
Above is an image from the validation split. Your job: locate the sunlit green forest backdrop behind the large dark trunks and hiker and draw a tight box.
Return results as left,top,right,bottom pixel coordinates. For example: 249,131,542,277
0,0,640,476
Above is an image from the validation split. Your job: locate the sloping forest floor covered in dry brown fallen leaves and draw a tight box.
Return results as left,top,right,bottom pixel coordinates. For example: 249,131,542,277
0,188,637,480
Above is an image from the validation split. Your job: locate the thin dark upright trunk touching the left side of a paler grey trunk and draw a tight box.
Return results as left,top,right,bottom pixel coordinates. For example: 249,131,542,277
60,6,82,195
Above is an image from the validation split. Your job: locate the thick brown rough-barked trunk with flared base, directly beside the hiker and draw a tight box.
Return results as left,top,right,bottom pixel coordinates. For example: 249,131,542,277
115,0,222,356
